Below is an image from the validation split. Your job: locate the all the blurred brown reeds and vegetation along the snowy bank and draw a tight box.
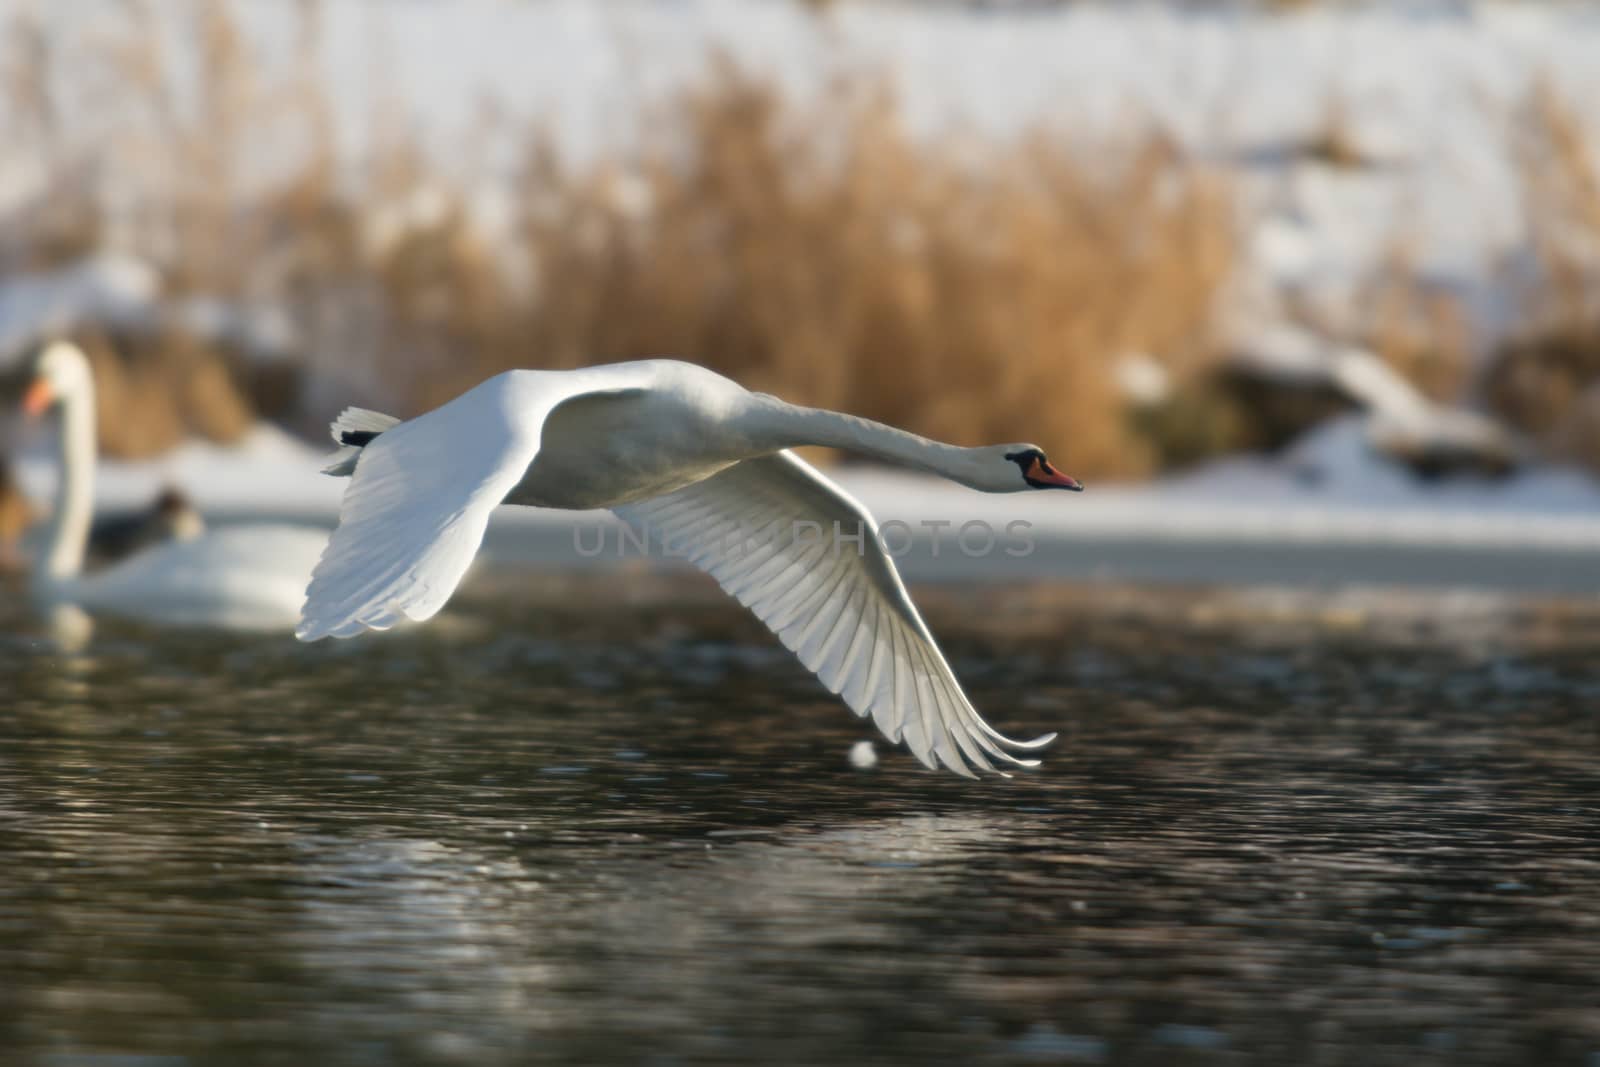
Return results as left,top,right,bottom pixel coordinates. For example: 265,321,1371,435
0,0,1600,478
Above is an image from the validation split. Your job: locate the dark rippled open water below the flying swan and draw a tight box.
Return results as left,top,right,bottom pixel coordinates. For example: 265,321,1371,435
0,576,1600,1067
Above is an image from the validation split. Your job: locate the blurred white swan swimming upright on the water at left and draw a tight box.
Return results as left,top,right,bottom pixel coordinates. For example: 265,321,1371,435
22,341,328,630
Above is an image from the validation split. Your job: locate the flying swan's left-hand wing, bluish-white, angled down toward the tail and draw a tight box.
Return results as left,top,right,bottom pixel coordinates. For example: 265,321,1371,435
294,376,539,641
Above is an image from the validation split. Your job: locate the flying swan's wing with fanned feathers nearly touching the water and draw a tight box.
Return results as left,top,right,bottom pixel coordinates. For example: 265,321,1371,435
614,453,1054,777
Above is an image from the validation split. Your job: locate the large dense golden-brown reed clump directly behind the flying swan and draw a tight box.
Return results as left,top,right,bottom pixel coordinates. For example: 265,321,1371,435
499,61,1234,475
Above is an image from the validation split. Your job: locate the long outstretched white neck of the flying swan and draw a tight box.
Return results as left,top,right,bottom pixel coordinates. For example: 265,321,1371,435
750,395,992,490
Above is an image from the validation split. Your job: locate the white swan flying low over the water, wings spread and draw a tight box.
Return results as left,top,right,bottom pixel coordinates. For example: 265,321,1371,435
296,360,1083,777
